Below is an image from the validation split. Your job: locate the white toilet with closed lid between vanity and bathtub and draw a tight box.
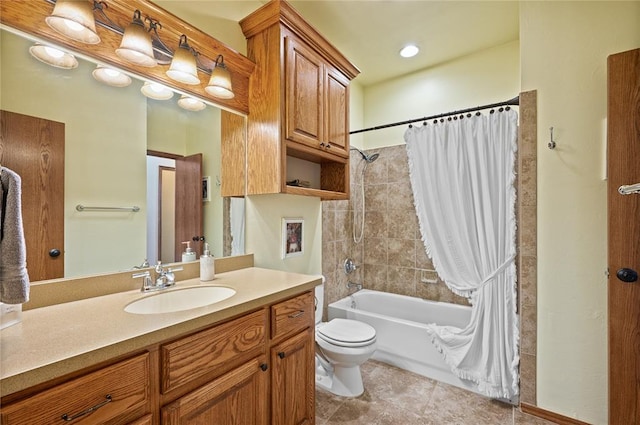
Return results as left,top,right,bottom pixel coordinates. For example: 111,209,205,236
316,284,376,397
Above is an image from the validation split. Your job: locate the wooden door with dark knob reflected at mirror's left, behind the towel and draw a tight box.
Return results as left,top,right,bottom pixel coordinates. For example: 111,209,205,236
0,111,65,282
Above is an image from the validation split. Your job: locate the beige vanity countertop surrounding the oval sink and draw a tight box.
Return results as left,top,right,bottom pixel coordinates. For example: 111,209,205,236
0,267,321,396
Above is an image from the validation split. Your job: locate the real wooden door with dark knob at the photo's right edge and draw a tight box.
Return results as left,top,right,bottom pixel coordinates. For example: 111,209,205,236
607,49,640,425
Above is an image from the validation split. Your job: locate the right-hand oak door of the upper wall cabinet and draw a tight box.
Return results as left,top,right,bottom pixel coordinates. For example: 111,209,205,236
324,66,349,158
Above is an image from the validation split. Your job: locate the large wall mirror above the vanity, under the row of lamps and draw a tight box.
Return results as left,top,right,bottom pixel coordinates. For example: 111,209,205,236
0,28,243,280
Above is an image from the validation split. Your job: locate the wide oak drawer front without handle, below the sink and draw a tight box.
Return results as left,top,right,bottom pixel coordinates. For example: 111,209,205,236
161,310,267,394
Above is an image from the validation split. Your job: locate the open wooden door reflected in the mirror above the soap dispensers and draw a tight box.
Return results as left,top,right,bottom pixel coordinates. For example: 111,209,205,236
175,153,204,261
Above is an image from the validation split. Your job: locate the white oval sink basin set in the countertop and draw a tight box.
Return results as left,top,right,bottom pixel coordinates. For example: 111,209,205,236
124,286,236,314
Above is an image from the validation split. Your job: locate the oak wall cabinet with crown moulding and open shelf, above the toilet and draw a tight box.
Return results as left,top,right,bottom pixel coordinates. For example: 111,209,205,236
231,0,359,199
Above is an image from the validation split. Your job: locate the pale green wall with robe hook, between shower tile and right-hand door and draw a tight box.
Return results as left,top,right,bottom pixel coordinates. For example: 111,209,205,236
520,1,640,424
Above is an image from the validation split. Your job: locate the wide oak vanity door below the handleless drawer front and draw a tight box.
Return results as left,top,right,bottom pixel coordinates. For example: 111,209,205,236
162,358,268,425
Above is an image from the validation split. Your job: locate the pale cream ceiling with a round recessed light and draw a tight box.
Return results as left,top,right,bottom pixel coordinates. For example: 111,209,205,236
156,0,519,86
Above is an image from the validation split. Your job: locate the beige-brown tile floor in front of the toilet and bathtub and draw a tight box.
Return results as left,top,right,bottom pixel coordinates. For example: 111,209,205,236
316,360,553,425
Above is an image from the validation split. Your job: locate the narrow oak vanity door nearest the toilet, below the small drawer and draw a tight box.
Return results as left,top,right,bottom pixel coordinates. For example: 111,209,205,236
271,328,315,425
